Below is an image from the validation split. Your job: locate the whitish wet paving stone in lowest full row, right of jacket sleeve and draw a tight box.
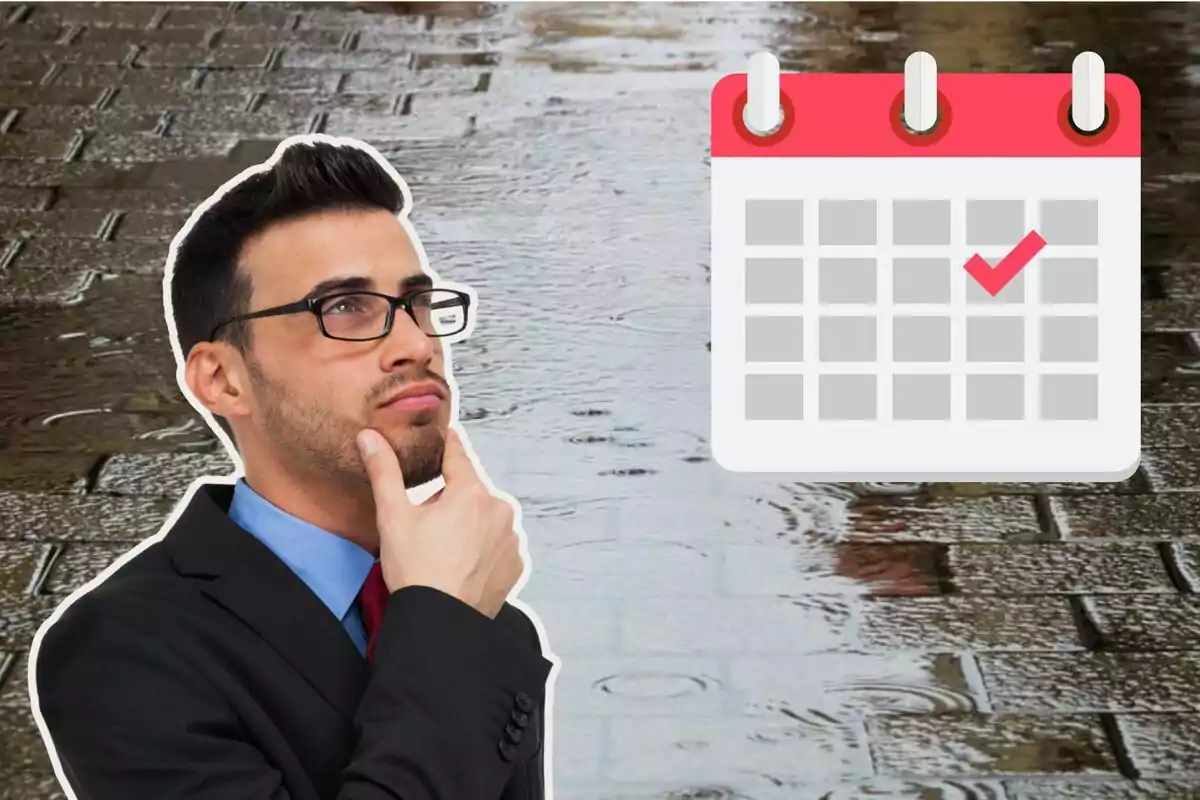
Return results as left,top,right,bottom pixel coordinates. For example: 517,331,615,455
604,716,870,796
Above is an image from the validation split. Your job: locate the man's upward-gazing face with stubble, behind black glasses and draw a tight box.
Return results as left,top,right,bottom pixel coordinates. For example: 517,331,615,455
234,210,450,487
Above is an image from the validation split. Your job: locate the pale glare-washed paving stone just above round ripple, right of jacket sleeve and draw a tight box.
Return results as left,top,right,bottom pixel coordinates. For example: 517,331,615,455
619,597,853,655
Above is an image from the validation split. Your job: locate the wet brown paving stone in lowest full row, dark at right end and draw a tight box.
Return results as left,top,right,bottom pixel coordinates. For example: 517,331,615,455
868,714,1120,777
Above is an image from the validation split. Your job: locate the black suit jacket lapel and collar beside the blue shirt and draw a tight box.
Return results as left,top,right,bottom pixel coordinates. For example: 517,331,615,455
163,483,367,720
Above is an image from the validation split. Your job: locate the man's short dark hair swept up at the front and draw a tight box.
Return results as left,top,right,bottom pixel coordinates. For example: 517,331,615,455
170,142,404,359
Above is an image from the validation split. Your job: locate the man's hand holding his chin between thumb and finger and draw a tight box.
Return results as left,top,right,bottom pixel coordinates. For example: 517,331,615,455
358,428,524,618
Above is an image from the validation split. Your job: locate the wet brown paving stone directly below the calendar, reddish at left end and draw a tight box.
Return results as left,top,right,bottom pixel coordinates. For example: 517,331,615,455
844,497,1042,542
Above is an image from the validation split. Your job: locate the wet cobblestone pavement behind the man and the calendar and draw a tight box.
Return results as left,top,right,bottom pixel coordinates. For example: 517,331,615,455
0,4,1200,800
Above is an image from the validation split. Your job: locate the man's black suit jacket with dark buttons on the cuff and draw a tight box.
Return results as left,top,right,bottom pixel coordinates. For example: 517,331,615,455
32,483,552,800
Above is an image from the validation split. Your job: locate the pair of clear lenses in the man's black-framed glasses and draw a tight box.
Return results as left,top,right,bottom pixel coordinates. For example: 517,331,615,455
318,289,467,339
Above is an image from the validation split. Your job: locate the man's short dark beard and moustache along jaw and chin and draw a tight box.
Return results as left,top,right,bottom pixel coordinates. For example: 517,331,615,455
247,357,449,488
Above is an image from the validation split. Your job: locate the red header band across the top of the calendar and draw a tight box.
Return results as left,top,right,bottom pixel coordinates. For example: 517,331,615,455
710,72,1141,158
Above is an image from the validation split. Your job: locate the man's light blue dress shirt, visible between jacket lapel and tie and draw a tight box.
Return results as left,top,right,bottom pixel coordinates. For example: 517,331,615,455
229,479,374,657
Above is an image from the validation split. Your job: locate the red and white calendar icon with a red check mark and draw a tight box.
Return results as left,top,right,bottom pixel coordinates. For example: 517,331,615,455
710,53,1141,481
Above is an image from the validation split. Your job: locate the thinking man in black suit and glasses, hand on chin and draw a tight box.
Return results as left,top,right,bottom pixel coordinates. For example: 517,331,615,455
30,137,553,800
